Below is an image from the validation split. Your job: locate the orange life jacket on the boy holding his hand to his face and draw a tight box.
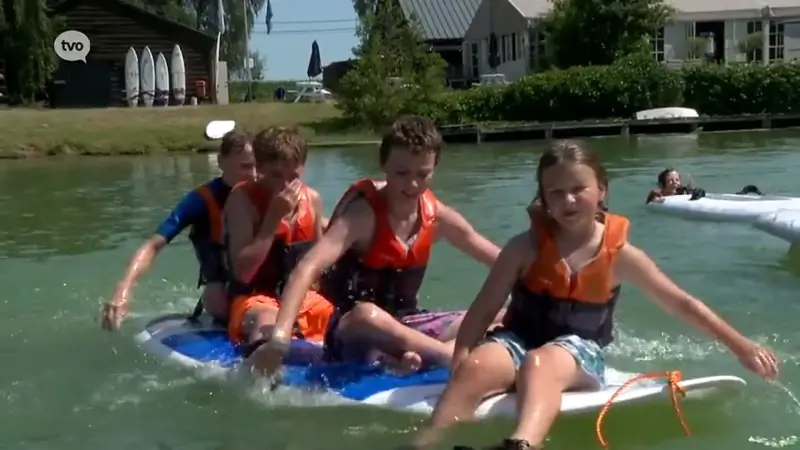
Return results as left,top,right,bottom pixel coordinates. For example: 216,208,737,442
229,181,318,298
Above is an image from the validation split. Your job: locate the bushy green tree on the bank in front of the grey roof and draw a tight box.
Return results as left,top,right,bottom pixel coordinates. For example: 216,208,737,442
337,0,445,128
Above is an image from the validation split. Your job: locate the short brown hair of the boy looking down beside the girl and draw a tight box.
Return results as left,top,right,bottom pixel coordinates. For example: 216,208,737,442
380,116,442,165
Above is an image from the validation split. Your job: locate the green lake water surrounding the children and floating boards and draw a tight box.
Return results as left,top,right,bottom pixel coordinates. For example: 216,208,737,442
0,133,800,450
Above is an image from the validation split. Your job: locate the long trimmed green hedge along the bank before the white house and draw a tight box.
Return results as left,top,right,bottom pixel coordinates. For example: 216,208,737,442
420,56,800,124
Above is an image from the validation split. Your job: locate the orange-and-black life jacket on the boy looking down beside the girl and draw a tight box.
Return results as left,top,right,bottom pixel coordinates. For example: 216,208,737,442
323,179,439,317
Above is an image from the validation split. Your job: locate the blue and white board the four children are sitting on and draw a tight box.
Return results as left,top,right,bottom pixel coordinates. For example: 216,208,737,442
135,314,746,418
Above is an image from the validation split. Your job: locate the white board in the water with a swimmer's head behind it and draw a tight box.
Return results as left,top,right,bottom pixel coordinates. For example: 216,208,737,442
647,193,800,222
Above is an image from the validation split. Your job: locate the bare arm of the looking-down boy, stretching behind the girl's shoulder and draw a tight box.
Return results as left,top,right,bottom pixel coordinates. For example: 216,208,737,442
436,202,500,267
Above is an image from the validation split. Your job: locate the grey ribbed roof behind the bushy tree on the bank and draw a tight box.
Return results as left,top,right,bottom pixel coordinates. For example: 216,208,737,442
400,0,481,40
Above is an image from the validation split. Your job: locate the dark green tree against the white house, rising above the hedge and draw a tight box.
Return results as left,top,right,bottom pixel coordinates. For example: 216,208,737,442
543,0,673,68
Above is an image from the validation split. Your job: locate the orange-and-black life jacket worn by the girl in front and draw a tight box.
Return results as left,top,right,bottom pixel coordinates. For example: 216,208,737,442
503,213,630,348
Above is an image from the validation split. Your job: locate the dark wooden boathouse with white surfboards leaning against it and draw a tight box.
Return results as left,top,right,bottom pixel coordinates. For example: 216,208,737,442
49,0,216,108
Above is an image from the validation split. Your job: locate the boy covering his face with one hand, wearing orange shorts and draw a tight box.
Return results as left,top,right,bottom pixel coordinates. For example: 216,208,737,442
225,127,333,371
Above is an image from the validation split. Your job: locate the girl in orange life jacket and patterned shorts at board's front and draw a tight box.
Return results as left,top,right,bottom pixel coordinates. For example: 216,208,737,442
415,142,778,450
